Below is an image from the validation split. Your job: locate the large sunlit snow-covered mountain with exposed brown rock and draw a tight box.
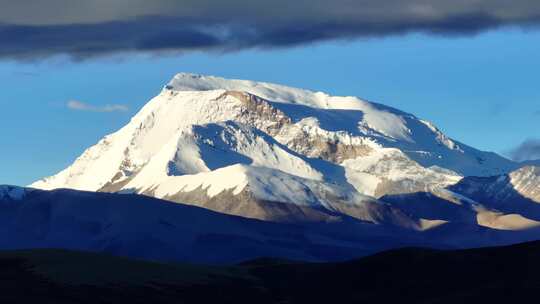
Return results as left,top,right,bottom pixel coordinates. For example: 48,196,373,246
31,74,538,230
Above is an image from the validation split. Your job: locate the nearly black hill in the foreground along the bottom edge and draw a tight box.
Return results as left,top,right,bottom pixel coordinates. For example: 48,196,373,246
0,242,540,303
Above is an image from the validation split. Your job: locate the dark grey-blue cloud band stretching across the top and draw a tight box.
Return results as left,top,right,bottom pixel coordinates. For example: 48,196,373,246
0,0,540,59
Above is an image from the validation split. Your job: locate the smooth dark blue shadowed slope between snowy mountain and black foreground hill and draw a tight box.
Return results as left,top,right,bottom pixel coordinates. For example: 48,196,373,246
0,187,434,263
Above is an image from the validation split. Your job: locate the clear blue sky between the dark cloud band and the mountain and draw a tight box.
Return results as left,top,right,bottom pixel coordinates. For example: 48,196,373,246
0,29,540,185
